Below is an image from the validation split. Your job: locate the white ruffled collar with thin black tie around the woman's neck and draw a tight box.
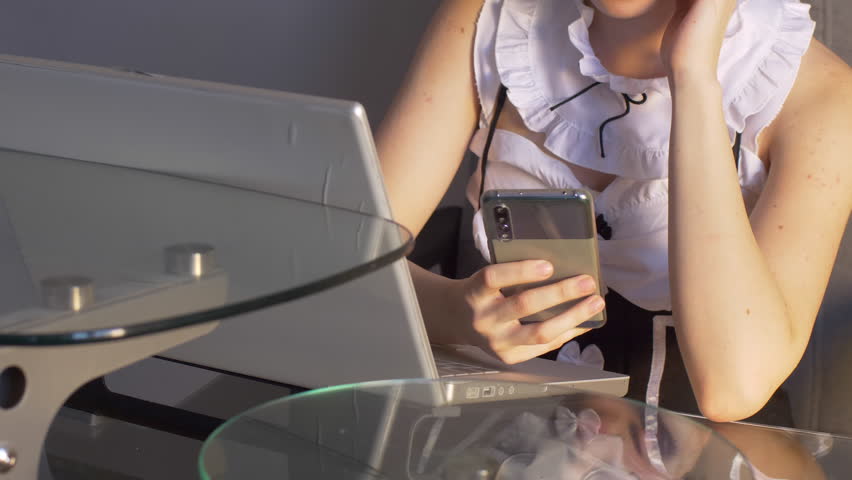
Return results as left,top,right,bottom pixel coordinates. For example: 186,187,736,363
492,0,814,180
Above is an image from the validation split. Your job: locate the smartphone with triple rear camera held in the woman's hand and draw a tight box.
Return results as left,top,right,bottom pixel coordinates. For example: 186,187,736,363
481,189,606,328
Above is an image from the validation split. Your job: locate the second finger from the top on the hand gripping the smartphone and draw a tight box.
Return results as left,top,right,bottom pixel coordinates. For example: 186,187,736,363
498,275,597,321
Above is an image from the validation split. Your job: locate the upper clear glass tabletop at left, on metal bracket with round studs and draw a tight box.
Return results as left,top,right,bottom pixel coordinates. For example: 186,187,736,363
0,150,412,345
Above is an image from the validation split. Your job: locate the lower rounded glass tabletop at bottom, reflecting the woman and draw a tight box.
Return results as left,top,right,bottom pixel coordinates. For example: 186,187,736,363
199,379,754,480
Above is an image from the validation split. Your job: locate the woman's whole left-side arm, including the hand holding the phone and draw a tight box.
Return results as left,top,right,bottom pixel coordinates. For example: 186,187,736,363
376,0,602,363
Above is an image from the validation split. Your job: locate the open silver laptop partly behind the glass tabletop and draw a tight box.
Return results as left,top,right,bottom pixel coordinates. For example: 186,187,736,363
0,56,628,401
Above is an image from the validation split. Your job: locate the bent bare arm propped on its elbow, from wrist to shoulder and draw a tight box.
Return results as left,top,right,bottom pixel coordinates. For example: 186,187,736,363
669,42,852,421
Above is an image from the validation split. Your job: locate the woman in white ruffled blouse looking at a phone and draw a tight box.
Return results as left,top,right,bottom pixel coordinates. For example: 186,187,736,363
377,0,852,421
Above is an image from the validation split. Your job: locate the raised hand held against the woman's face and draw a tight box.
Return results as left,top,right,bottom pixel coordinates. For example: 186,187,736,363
661,0,737,80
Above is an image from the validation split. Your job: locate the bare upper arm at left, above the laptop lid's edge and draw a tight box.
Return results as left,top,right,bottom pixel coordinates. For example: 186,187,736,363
376,0,482,235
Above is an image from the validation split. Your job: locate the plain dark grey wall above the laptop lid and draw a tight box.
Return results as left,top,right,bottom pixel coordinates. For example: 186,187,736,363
0,0,439,127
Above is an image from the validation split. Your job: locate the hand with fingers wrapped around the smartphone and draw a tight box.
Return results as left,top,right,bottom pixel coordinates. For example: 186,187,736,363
449,260,604,364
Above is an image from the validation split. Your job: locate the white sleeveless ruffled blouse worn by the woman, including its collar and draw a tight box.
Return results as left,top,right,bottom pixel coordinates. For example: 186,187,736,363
468,0,814,311
